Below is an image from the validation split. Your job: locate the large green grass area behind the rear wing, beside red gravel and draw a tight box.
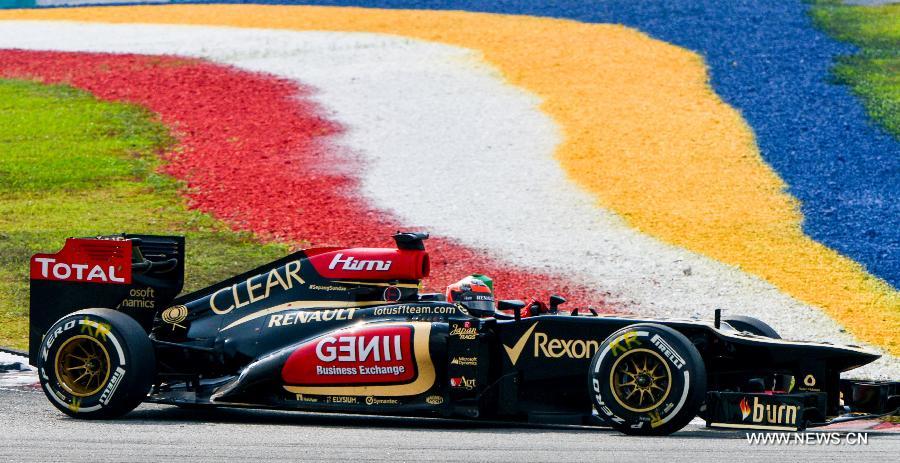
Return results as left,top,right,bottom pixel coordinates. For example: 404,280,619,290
0,80,288,349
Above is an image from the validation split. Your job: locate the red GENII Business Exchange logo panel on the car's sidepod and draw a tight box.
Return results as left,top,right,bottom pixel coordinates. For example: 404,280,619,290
282,326,416,385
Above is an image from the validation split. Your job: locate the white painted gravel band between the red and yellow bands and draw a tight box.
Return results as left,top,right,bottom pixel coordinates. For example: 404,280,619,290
0,21,900,377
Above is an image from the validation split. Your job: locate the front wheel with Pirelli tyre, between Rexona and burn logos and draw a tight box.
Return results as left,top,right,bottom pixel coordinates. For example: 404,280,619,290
589,323,706,435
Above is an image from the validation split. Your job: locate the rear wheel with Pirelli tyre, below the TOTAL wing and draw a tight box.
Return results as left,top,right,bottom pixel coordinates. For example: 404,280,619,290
37,309,156,419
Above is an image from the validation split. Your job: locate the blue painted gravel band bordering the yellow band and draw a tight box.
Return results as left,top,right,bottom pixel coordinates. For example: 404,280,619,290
74,0,900,288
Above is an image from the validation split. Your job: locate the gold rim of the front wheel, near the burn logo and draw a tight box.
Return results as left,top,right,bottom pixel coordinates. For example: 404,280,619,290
609,349,672,413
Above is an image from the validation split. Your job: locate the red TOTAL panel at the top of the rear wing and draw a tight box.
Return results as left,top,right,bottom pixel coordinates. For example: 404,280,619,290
31,238,131,284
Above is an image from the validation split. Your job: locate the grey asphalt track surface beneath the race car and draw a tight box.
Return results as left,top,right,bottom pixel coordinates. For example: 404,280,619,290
0,388,900,463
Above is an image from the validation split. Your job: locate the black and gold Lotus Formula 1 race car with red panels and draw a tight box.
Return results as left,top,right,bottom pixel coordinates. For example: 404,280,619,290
29,232,900,435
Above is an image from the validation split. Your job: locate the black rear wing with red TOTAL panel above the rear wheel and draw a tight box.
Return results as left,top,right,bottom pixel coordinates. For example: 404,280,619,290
28,234,184,365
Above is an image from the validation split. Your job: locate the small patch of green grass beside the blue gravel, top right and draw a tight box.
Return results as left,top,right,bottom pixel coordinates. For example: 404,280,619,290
811,0,900,139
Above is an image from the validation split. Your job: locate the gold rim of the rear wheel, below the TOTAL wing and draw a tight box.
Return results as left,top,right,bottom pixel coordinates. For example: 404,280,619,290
54,335,110,397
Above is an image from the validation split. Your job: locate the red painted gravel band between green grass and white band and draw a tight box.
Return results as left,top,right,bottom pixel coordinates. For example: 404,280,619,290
0,50,603,305
